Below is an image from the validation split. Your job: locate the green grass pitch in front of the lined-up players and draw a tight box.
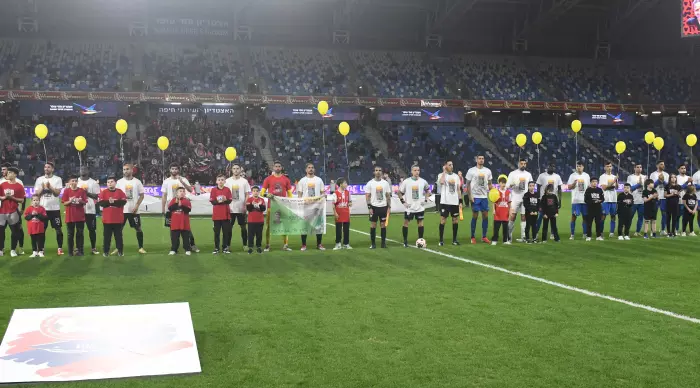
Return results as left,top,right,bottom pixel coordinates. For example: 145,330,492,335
0,194,700,388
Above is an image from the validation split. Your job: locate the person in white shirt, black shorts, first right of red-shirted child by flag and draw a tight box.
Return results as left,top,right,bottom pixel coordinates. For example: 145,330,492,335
365,166,394,249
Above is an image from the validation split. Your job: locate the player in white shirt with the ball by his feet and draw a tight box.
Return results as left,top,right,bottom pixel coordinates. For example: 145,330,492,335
398,166,430,248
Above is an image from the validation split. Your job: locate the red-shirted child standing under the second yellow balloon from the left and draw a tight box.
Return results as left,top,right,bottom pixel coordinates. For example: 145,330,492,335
61,175,87,256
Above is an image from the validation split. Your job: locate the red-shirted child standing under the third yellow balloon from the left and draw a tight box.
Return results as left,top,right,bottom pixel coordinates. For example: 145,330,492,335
97,175,126,257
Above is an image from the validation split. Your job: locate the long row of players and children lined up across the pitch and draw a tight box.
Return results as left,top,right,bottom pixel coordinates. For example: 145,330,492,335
0,155,700,257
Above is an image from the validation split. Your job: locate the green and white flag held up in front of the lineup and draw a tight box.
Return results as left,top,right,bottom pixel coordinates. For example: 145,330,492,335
268,197,326,236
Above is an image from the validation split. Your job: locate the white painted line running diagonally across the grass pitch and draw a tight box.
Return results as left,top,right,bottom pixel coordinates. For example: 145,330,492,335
328,223,700,324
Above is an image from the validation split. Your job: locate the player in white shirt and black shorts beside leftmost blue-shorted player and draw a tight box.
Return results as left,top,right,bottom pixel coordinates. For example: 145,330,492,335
436,160,462,246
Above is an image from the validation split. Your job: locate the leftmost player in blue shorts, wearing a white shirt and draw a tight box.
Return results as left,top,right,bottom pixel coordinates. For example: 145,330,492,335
464,155,493,244
